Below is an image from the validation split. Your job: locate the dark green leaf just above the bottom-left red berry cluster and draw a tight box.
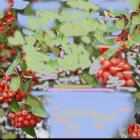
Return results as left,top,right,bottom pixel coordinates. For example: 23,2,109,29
9,97,20,113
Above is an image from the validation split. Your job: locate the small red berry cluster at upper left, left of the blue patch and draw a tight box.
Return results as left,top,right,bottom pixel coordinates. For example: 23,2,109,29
2,11,15,25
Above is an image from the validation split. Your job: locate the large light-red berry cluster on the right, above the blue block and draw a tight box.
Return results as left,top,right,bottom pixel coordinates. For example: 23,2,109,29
96,56,135,87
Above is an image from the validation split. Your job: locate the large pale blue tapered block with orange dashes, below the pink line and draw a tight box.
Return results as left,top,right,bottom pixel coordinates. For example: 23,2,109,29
32,92,135,138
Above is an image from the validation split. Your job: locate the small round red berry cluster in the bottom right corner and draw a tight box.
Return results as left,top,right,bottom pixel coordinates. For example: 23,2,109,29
128,124,140,138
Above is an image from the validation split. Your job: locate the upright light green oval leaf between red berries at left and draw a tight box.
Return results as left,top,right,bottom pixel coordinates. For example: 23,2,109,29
9,76,20,91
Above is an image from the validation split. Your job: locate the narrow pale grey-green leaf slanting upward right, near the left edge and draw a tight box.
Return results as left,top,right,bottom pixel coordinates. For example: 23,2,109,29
6,59,20,75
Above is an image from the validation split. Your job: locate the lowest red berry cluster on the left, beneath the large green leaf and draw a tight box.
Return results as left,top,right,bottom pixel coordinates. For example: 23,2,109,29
8,110,40,128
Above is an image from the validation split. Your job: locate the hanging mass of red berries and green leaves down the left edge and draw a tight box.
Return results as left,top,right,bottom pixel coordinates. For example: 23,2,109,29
0,0,46,137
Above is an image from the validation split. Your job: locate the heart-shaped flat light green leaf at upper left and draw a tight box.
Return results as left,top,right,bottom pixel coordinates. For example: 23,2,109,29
8,31,25,45
